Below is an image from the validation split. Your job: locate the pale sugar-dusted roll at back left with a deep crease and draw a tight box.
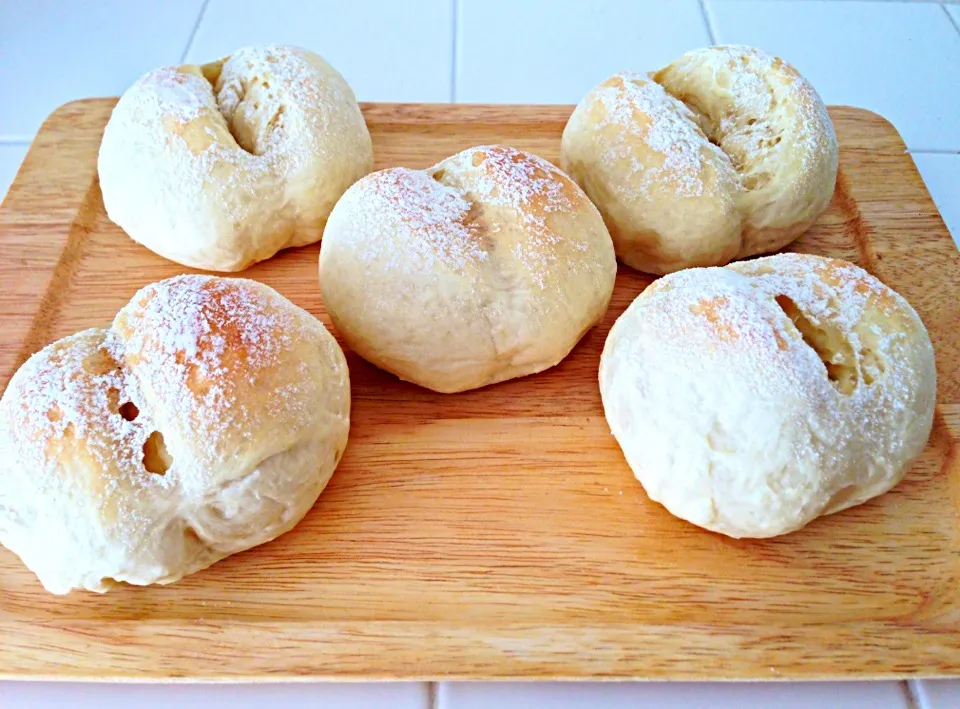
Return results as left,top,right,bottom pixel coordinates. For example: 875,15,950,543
97,47,373,271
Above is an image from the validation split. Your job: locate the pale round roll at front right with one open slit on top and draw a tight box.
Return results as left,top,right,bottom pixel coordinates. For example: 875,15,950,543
600,254,937,537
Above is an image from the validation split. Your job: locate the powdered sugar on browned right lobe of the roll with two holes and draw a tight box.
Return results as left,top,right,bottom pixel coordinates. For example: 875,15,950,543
111,275,302,478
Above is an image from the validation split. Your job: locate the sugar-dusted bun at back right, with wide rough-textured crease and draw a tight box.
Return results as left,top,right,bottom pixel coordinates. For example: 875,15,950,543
561,46,838,274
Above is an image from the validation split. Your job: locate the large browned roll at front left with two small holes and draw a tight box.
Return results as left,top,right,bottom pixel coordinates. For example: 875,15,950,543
0,276,350,594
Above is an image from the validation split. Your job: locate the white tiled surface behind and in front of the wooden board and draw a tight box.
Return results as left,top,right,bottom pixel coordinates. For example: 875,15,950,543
0,0,960,709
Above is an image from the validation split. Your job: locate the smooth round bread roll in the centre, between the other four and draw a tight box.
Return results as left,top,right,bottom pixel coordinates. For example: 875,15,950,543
320,146,617,392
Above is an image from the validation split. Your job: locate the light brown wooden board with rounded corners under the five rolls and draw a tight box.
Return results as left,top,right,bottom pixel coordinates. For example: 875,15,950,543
0,99,960,680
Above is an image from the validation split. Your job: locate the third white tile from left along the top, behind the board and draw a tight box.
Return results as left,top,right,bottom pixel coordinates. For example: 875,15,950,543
456,0,710,103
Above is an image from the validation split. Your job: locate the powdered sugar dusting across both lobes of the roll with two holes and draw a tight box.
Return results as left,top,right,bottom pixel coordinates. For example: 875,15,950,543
5,276,310,506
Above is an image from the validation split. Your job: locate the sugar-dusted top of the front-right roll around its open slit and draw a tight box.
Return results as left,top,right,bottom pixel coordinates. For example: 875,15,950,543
643,254,922,432
